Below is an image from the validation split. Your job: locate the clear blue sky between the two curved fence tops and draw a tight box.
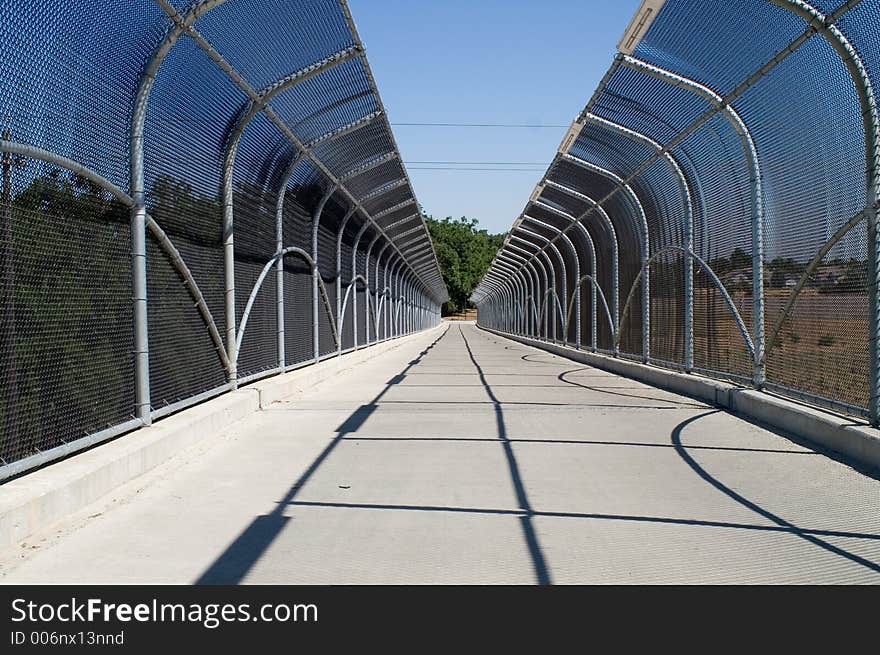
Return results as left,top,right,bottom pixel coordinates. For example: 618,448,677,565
349,0,639,232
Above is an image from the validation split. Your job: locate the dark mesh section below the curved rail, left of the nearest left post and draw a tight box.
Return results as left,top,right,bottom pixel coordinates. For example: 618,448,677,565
0,167,134,462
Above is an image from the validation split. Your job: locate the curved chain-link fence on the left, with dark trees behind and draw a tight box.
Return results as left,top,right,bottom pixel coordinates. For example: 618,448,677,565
0,0,447,479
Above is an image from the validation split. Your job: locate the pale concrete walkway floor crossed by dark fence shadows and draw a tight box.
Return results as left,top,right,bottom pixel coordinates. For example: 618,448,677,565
0,323,880,584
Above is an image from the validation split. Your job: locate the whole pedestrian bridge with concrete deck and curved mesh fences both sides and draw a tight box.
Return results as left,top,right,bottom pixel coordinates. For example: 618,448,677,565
0,0,880,584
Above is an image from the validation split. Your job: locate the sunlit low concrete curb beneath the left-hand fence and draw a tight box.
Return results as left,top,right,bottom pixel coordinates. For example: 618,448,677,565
0,326,442,548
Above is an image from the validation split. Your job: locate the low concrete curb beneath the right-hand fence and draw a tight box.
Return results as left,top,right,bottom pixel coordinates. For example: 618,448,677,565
477,326,880,470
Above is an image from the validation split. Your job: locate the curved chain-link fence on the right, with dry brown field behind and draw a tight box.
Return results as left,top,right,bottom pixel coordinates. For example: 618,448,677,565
472,0,880,425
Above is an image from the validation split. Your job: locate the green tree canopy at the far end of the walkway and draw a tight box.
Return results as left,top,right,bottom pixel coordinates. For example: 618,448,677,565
425,214,506,315
